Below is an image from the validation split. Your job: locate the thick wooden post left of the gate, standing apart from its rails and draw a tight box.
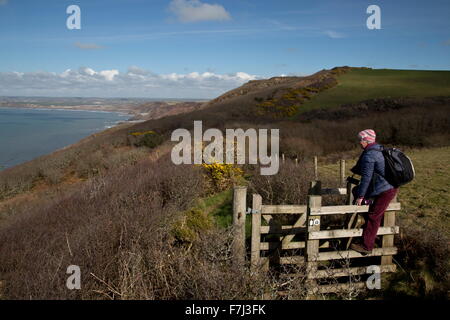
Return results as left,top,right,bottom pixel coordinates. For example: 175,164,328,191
232,186,247,266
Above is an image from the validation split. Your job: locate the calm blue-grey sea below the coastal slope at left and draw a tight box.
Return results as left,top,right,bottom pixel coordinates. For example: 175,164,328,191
0,107,131,171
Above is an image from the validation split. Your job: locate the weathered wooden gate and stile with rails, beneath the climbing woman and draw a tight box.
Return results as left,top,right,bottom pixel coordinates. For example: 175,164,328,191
251,181,400,294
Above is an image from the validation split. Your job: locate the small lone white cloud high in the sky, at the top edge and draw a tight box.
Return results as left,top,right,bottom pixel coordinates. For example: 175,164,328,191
169,0,231,22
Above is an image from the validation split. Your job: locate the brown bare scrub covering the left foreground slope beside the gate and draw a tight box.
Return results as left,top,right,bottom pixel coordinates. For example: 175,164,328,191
0,152,282,299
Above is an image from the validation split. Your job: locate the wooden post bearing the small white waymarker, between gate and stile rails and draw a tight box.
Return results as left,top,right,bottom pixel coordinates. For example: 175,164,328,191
306,181,322,296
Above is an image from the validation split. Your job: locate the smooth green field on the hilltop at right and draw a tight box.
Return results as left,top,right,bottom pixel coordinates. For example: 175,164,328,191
301,69,450,112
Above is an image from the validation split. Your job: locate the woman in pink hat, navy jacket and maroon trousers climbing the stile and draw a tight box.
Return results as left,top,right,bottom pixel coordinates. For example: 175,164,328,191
350,129,398,255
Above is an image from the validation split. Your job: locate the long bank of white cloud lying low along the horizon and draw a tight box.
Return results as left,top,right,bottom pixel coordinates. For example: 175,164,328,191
0,66,259,99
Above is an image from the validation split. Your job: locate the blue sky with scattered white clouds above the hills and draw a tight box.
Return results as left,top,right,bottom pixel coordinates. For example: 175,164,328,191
0,0,450,98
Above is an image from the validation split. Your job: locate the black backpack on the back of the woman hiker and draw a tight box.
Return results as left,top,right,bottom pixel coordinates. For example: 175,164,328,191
382,147,416,188
